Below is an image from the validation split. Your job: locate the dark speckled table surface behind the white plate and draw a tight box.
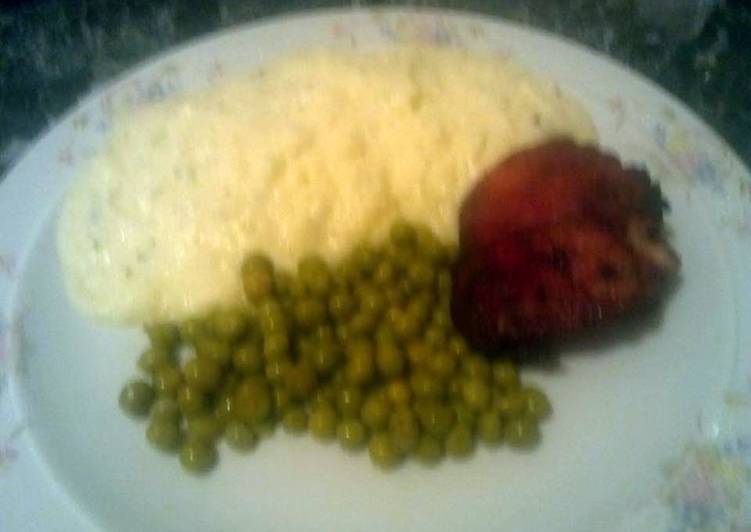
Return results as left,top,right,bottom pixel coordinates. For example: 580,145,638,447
0,0,751,179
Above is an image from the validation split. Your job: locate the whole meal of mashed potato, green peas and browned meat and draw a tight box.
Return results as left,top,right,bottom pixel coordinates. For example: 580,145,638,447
58,47,678,472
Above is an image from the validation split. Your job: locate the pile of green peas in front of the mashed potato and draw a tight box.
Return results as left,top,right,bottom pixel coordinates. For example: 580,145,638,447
120,221,551,472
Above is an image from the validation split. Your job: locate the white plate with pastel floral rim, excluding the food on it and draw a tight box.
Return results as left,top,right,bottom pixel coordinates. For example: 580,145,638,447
0,10,751,532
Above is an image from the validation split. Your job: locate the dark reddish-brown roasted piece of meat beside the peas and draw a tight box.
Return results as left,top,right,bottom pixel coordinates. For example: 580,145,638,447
451,140,680,349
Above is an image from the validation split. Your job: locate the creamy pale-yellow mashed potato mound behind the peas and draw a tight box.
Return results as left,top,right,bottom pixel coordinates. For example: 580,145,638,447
58,48,595,323
